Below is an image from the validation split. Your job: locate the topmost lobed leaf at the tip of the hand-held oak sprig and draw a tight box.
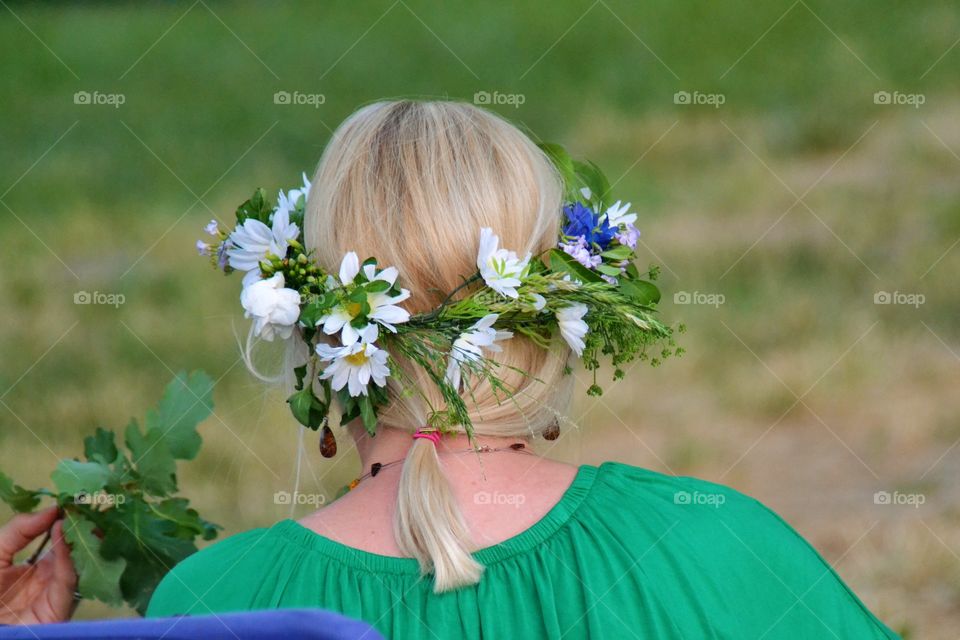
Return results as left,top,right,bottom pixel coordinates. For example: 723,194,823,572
145,371,213,460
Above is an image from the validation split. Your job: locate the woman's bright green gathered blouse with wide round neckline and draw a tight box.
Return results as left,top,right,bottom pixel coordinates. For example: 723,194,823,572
147,462,897,640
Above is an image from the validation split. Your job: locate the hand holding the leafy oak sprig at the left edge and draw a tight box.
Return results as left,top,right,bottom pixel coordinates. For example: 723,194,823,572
0,507,77,624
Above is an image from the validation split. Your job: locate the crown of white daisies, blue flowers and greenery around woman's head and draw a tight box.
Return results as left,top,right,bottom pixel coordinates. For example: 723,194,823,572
197,144,683,456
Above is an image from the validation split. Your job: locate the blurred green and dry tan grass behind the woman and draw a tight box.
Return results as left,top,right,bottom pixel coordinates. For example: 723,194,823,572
0,0,960,638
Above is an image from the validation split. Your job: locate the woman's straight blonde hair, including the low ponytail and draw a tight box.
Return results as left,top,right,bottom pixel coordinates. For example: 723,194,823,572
290,100,569,592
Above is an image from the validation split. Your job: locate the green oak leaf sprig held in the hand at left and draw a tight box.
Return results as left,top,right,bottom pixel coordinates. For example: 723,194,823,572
0,371,221,615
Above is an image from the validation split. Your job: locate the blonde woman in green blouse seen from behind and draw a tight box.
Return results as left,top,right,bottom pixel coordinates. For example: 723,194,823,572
142,101,896,639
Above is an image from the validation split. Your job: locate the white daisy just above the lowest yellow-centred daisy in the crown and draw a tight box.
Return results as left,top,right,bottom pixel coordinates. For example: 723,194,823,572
317,251,410,345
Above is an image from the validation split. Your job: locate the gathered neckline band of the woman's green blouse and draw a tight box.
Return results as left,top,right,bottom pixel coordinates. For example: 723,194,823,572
268,463,607,574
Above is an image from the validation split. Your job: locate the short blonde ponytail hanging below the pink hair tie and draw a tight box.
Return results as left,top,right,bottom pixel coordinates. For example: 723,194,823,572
393,438,483,593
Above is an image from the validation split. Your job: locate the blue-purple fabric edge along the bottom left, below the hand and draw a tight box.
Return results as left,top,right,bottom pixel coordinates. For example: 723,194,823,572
0,609,383,640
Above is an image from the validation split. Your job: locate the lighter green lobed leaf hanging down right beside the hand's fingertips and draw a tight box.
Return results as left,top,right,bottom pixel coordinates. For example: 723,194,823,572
63,511,127,606
